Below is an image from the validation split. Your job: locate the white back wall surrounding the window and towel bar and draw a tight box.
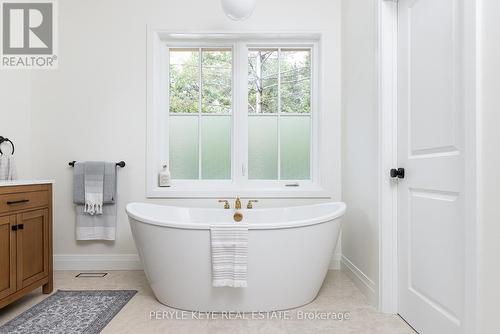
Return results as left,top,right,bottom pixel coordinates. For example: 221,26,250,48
25,0,340,268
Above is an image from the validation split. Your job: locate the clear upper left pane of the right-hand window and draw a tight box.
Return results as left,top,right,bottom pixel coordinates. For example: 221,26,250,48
248,49,278,114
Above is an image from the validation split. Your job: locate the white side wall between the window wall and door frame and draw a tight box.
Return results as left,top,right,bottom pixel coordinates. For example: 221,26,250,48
342,0,378,302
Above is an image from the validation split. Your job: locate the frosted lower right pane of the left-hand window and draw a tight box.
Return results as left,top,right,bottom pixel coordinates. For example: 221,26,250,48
201,116,231,180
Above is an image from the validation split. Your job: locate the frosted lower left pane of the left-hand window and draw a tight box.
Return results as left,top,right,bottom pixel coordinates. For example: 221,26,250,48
169,116,198,179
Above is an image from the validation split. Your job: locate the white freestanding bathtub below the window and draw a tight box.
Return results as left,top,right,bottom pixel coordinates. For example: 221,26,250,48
127,202,346,312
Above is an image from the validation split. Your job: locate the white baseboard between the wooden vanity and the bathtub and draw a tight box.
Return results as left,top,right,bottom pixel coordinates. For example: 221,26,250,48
54,254,142,270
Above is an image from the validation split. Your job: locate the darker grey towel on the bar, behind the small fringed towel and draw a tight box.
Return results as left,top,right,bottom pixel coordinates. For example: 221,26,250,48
73,162,116,204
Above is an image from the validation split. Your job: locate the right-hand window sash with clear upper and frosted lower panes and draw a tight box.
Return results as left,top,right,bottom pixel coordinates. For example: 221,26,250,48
248,48,312,180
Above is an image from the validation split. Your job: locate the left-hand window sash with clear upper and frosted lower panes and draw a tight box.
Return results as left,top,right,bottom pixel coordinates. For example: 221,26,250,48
169,48,232,180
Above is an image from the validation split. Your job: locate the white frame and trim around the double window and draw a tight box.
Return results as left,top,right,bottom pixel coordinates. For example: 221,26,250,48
146,29,329,198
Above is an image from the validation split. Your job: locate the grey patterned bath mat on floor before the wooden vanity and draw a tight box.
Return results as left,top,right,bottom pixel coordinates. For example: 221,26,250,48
0,290,137,334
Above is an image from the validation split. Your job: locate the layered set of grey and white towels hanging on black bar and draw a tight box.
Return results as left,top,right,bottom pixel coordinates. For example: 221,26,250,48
73,162,117,240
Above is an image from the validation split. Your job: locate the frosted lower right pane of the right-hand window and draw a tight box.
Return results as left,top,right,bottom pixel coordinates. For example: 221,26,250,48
280,116,311,180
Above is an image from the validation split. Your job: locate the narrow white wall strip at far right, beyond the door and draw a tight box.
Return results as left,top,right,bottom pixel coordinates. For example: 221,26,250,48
477,0,500,334
